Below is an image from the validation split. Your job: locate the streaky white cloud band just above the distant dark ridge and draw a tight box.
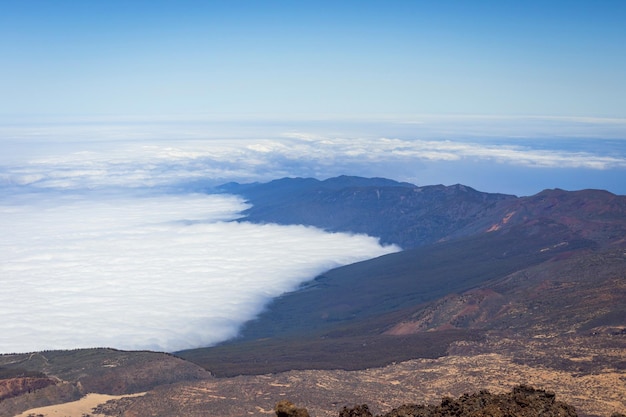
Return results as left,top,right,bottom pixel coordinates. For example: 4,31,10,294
0,138,626,195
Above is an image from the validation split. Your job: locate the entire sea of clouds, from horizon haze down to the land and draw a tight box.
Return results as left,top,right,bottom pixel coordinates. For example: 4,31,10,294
0,118,626,353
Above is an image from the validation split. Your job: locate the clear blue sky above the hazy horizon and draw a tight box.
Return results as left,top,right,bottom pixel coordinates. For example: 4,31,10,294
0,0,626,118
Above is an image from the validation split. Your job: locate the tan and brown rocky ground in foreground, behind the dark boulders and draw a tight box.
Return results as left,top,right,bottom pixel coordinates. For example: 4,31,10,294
67,337,626,417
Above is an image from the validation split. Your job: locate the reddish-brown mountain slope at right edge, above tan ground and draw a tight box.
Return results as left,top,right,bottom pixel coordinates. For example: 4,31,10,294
387,249,626,337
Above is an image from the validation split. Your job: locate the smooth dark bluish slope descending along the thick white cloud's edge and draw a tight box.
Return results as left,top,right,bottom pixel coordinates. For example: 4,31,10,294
229,224,594,339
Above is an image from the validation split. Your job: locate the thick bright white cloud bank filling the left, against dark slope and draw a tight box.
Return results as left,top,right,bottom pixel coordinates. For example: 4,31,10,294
0,195,396,352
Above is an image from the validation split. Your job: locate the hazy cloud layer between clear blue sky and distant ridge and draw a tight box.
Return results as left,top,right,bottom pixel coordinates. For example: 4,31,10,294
0,117,626,194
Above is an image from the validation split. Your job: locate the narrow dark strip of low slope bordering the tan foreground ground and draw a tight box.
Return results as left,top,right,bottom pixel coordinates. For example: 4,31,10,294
179,330,482,377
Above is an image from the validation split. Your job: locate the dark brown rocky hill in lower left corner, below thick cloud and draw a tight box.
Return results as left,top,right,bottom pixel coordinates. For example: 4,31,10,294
0,349,212,417
